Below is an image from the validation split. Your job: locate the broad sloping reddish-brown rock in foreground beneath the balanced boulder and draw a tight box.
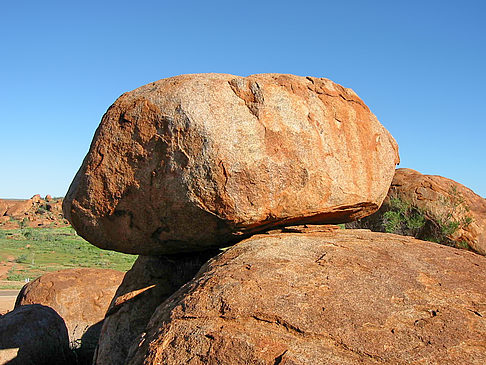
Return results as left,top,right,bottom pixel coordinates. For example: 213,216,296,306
128,229,486,365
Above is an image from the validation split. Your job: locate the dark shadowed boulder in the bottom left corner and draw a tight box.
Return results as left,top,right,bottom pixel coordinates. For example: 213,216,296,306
0,304,74,365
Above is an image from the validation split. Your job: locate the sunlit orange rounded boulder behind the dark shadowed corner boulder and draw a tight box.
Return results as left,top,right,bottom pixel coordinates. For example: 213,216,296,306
15,269,124,352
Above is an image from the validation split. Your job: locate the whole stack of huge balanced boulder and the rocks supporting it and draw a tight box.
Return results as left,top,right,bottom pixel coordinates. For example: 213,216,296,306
3,74,486,365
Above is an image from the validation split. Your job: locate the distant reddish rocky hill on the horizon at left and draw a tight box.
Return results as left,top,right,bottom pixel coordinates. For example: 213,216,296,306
0,194,69,229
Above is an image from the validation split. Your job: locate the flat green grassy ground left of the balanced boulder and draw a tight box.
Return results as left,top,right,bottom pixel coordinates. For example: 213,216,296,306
0,226,136,289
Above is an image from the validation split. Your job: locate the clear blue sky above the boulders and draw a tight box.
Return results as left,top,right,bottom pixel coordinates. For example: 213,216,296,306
0,0,486,198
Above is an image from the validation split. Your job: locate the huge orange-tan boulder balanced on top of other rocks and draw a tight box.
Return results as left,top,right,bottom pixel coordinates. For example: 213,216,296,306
64,74,398,255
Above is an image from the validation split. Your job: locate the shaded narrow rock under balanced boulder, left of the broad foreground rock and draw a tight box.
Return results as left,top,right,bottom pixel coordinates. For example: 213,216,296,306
93,251,218,365
